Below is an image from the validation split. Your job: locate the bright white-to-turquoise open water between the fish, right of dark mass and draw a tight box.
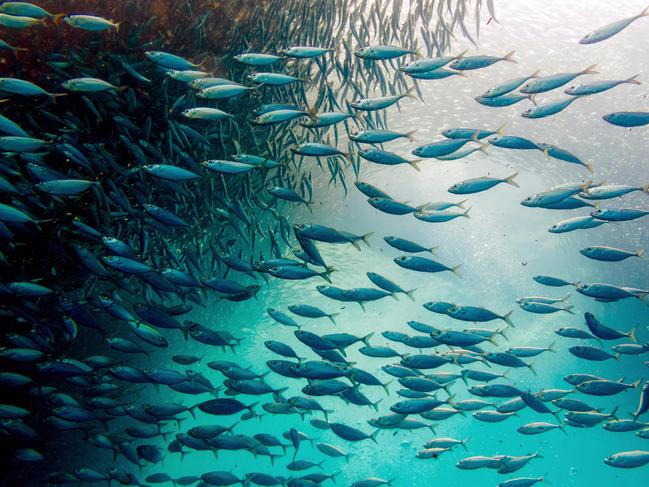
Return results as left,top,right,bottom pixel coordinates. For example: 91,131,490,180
45,0,649,487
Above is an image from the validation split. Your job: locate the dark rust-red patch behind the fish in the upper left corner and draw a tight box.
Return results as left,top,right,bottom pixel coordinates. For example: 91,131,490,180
0,0,264,81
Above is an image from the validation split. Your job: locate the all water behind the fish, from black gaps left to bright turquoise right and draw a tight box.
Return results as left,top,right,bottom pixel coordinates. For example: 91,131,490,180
0,0,649,487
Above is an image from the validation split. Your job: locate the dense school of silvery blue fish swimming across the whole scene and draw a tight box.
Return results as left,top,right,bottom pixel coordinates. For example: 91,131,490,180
0,0,649,487
